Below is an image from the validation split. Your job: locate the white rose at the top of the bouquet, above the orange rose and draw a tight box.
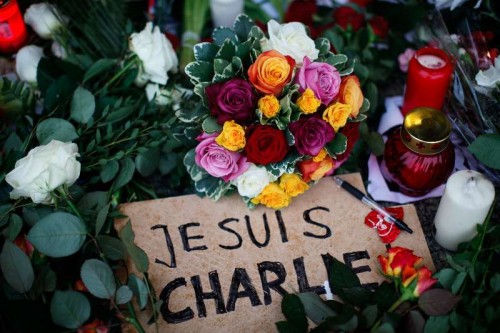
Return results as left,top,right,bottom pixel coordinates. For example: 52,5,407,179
263,20,319,65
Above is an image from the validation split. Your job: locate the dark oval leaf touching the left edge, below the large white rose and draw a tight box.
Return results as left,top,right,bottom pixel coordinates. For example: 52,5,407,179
0,240,35,293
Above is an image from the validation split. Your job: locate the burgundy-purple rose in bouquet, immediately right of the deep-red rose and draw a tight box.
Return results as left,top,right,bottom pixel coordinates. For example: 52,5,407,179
289,116,335,156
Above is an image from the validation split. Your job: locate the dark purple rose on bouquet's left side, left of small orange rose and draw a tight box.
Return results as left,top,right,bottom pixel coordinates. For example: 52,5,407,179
205,79,257,125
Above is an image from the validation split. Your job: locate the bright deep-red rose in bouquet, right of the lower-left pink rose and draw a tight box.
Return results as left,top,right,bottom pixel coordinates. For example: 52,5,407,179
245,125,289,165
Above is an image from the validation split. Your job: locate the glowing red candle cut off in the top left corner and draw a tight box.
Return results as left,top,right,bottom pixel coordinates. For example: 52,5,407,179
0,0,28,53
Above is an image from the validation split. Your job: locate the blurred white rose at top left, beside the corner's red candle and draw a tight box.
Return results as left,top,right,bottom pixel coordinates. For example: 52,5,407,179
24,2,63,39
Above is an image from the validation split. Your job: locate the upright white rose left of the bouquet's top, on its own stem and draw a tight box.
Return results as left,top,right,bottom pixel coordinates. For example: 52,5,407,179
129,22,179,85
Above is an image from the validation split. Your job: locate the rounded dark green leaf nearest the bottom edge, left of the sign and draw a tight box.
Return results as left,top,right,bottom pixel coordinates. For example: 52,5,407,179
50,290,90,329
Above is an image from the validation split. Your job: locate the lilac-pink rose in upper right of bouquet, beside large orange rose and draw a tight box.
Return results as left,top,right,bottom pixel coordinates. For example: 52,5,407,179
295,57,340,105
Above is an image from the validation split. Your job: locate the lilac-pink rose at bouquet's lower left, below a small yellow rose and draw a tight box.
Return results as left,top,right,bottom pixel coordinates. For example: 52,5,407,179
195,133,250,182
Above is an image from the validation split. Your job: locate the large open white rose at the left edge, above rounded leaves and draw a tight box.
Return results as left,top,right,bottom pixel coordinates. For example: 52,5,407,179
5,140,80,203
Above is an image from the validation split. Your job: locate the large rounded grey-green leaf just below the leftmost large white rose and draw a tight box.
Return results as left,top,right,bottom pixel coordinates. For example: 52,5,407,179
28,212,87,258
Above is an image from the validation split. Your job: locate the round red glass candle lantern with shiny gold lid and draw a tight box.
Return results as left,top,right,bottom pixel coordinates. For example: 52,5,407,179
381,108,455,196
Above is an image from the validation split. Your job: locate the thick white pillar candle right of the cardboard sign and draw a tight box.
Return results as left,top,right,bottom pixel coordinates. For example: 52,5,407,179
434,170,495,251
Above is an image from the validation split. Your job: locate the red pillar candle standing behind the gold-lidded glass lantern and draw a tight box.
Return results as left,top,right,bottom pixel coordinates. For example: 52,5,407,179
401,47,453,116
